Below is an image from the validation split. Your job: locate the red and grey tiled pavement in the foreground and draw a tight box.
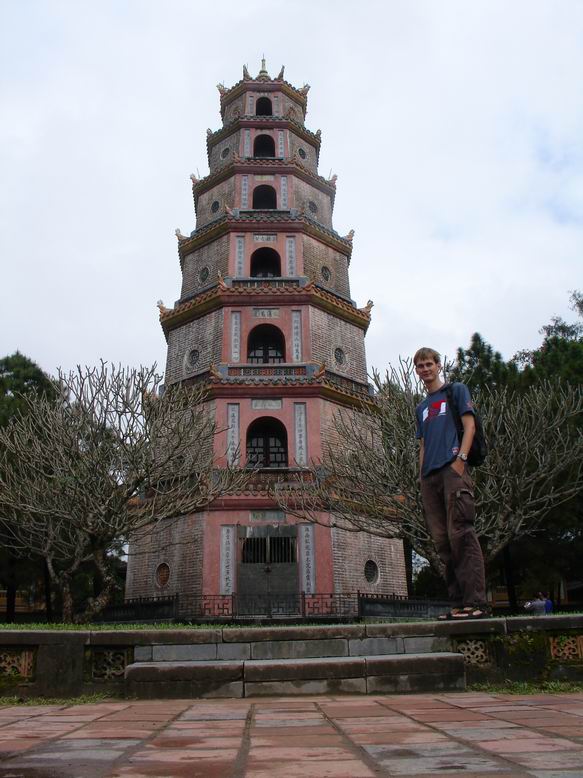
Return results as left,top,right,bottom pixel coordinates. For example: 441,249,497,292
0,692,583,778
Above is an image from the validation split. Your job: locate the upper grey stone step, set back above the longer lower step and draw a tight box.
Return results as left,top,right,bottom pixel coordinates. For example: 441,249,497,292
134,630,452,662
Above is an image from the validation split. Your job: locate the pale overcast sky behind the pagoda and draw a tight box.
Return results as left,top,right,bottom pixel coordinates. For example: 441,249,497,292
0,0,583,372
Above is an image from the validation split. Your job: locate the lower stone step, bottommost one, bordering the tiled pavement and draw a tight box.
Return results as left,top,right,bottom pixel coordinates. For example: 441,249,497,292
125,651,465,698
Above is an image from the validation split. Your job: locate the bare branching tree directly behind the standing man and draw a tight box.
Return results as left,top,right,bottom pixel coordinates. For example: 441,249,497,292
274,361,583,572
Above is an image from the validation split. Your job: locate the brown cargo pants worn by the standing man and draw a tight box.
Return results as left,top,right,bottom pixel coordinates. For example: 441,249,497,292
421,465,486,607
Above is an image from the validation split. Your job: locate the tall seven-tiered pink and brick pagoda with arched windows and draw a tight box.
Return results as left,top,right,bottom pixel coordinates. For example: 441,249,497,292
126,60,406,618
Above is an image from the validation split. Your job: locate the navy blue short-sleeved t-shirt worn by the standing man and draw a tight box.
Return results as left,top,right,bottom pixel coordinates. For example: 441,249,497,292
416,384,474,476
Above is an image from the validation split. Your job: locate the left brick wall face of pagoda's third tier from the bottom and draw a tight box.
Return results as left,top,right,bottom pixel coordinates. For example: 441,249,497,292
165,310,223,385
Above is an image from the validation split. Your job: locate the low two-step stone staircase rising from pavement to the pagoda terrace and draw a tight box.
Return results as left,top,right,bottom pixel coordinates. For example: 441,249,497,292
125,622,470,699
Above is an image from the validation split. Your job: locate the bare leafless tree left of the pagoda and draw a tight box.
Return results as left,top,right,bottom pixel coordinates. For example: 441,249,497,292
0,363,249,621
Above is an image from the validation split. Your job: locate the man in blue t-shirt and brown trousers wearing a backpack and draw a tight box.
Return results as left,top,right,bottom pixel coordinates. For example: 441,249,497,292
413,348,489,620
